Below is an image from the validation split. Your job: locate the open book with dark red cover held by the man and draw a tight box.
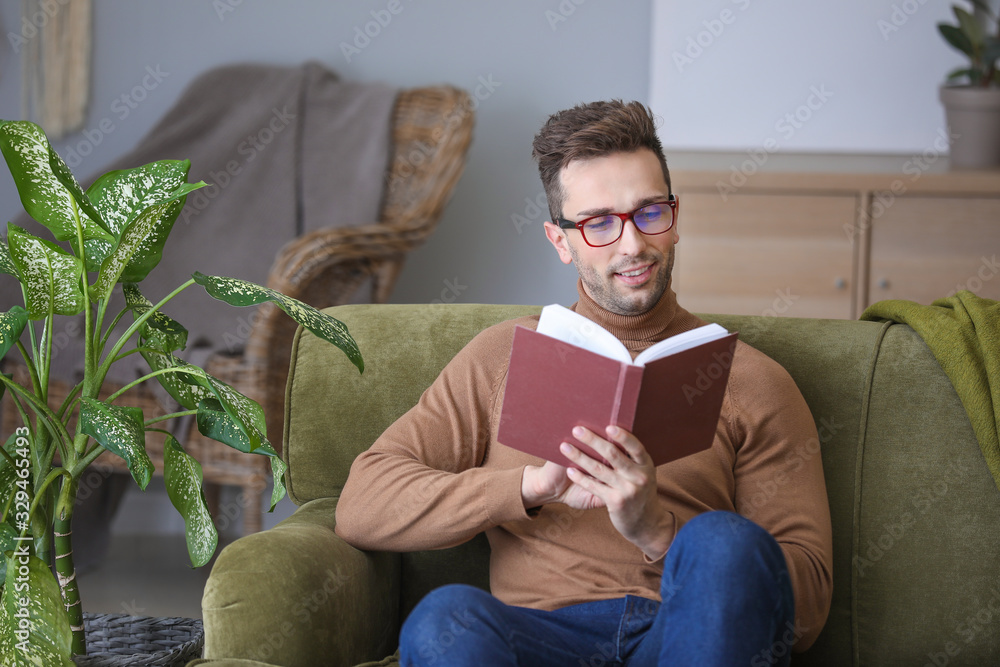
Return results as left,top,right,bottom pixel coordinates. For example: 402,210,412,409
498,305,737,466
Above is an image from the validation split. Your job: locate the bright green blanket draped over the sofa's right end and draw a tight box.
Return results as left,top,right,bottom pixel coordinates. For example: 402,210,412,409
861,290,1000,496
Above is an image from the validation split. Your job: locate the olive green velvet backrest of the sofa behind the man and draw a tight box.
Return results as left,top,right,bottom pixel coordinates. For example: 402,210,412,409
284,304,1000,667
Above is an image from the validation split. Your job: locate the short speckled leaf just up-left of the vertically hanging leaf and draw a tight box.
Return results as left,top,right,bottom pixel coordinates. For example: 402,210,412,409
80,398,153,490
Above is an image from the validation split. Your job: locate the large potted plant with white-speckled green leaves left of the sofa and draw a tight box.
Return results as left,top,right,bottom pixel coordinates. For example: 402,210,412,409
0,121,363,667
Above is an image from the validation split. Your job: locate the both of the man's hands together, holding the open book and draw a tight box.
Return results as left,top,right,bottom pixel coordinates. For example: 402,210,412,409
521,426,671,559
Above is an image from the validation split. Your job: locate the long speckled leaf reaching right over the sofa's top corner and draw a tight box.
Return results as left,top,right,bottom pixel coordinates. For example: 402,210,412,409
193,273,365,372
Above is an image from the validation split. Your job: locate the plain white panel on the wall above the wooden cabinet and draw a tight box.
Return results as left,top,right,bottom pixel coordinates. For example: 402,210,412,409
650,0,962,153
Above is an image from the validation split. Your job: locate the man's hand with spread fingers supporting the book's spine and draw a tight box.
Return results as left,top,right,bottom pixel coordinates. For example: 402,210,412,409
560,426,672,560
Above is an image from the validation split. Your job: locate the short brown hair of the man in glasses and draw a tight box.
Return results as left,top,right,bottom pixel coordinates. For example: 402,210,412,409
531,100,670,219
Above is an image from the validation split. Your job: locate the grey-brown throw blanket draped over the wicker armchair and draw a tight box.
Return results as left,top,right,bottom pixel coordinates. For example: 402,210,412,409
0,62,396,382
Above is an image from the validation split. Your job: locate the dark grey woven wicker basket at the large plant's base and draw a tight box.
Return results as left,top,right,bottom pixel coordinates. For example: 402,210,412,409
73,613,205,667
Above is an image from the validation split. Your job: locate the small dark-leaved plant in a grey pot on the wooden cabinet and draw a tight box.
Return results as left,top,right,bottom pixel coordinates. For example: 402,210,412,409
938,0,1000,169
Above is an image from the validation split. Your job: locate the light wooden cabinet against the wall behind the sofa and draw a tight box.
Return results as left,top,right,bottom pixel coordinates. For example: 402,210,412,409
668,156,1000,319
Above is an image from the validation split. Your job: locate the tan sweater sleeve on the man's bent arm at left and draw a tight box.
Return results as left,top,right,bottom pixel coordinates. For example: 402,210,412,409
336,326,528,551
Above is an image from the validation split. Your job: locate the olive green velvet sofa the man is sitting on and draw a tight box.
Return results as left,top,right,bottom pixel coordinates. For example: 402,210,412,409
192,304,1000,667
